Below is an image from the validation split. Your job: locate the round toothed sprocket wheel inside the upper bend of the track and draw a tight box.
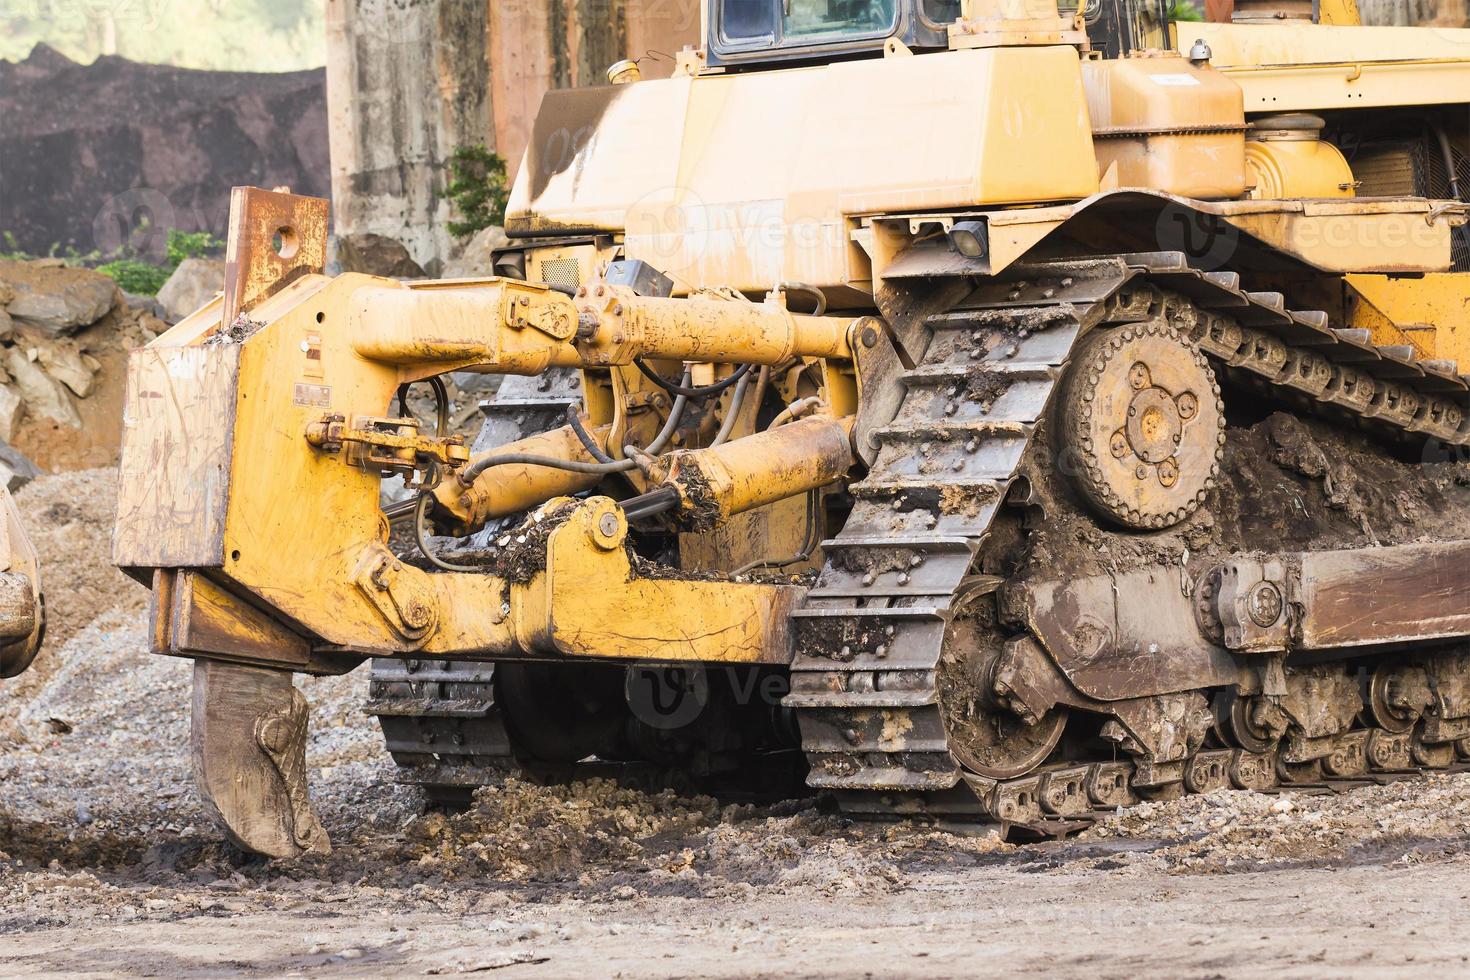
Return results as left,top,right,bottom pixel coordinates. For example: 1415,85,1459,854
1061,320,1225,530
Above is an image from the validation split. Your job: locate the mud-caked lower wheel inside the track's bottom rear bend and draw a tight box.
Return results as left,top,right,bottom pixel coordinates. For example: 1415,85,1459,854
939,589,1067,779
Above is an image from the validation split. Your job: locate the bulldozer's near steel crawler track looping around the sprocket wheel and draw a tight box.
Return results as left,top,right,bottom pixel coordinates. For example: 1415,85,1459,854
785,253,1470,833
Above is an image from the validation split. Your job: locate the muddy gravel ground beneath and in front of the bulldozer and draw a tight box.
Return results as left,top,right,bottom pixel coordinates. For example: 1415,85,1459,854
0,470,1470,977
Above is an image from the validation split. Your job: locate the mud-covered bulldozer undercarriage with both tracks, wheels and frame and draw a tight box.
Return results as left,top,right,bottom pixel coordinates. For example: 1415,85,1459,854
372,254,1470,833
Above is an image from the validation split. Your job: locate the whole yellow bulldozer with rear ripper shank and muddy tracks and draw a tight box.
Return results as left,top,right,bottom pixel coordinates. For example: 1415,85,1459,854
113,0,1470,857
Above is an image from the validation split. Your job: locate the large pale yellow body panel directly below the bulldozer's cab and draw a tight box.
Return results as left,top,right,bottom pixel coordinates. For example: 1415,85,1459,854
509,47,1098,291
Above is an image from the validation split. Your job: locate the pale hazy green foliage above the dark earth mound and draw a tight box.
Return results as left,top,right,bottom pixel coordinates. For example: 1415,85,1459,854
0,0,326,72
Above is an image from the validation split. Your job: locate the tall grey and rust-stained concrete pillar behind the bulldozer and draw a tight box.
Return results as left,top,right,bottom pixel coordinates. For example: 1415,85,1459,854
326,0,703,273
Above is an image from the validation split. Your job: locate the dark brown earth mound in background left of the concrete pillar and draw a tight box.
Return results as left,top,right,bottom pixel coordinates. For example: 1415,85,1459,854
0,46,329,259
